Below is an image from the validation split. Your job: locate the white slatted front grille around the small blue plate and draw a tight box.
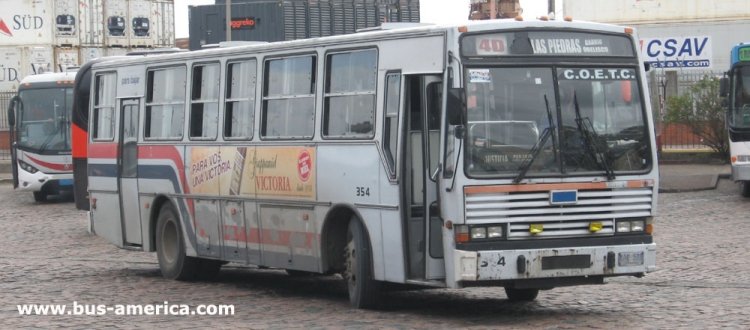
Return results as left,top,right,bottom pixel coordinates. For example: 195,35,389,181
466,187,653,239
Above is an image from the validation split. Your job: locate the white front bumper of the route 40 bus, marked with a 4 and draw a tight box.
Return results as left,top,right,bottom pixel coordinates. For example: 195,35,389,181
454,243,656,282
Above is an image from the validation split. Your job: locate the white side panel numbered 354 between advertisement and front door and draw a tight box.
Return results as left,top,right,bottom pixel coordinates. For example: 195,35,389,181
317,144,394,280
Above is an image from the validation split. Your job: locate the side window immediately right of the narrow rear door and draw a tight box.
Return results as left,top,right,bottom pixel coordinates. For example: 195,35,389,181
144,67,186,140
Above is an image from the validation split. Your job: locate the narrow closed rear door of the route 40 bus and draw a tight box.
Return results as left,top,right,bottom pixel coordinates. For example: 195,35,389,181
118,99,142,245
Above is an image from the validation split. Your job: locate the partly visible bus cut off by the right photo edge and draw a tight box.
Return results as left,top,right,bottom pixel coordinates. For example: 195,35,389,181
721,44,750,197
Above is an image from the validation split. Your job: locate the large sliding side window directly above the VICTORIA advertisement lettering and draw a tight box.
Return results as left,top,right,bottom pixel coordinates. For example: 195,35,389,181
260,56,315,139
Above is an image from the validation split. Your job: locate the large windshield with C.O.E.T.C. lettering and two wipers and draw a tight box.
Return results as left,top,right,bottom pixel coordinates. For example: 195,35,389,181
466,67,650,178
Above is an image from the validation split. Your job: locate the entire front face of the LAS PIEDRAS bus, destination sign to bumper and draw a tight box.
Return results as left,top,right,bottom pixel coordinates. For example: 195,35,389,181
442,28,658,288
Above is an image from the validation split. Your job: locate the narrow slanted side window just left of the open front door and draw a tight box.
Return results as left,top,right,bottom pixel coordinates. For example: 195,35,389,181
383,73,401,176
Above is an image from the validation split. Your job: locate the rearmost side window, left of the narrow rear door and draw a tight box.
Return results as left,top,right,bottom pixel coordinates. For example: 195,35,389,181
91,72,117,141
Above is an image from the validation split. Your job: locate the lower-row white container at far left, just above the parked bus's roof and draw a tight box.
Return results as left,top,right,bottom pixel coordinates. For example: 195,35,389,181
0,45,54,91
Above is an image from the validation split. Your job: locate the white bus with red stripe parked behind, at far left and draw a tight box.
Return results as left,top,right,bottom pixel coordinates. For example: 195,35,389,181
8,72,75,202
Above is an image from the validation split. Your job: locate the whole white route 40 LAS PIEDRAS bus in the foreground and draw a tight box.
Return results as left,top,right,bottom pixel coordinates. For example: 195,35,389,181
81,20,658,308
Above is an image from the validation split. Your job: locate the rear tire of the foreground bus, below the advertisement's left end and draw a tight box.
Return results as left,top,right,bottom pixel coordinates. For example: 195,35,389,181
156,203,200,281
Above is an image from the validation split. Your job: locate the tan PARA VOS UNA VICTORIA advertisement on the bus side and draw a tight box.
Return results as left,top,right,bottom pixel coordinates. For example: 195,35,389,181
187,147,316,199
